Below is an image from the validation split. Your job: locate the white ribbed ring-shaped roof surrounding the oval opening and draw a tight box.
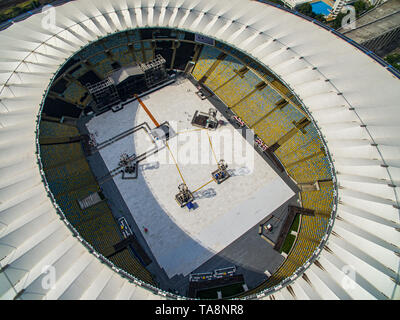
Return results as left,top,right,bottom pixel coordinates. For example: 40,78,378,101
0,0,400,299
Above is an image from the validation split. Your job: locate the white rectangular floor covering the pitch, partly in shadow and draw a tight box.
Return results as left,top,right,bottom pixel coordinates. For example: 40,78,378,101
87,80,294,278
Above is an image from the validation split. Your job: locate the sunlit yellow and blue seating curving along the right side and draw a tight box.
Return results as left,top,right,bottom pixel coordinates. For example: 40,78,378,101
192,44,333,294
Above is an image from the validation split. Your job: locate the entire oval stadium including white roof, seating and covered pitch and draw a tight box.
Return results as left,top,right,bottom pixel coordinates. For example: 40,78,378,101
0,0,400,300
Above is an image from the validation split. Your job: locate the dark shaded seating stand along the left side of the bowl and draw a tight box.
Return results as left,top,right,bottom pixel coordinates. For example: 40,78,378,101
40,121,154,284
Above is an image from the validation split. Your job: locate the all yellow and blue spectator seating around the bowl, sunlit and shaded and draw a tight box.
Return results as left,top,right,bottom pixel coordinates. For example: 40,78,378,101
41,37,334,290
